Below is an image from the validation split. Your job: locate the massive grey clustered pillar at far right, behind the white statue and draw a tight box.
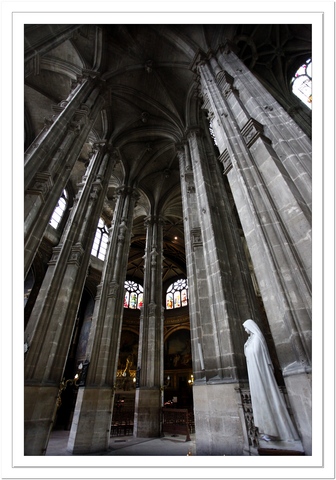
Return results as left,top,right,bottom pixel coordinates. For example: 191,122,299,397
197,45,312,454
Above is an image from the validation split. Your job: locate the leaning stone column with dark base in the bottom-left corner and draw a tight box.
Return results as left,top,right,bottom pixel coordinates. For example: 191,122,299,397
24,142,114,455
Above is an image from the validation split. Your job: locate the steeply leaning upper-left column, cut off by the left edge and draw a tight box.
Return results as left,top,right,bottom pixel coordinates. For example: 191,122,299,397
24,74,104,275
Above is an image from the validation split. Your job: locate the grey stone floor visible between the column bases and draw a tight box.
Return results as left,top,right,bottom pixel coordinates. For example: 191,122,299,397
46,430,196,456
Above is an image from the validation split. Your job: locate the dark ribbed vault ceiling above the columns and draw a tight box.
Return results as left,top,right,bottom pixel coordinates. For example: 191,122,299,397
25,25,311,281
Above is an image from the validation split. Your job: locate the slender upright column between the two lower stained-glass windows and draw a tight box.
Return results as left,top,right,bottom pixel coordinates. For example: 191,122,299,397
134,216,164,437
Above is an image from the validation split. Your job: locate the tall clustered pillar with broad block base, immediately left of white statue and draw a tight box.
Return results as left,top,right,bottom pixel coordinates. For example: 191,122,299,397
179,128,258,455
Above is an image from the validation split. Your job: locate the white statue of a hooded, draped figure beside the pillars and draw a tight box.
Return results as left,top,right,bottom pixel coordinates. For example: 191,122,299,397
243,319,299,441
